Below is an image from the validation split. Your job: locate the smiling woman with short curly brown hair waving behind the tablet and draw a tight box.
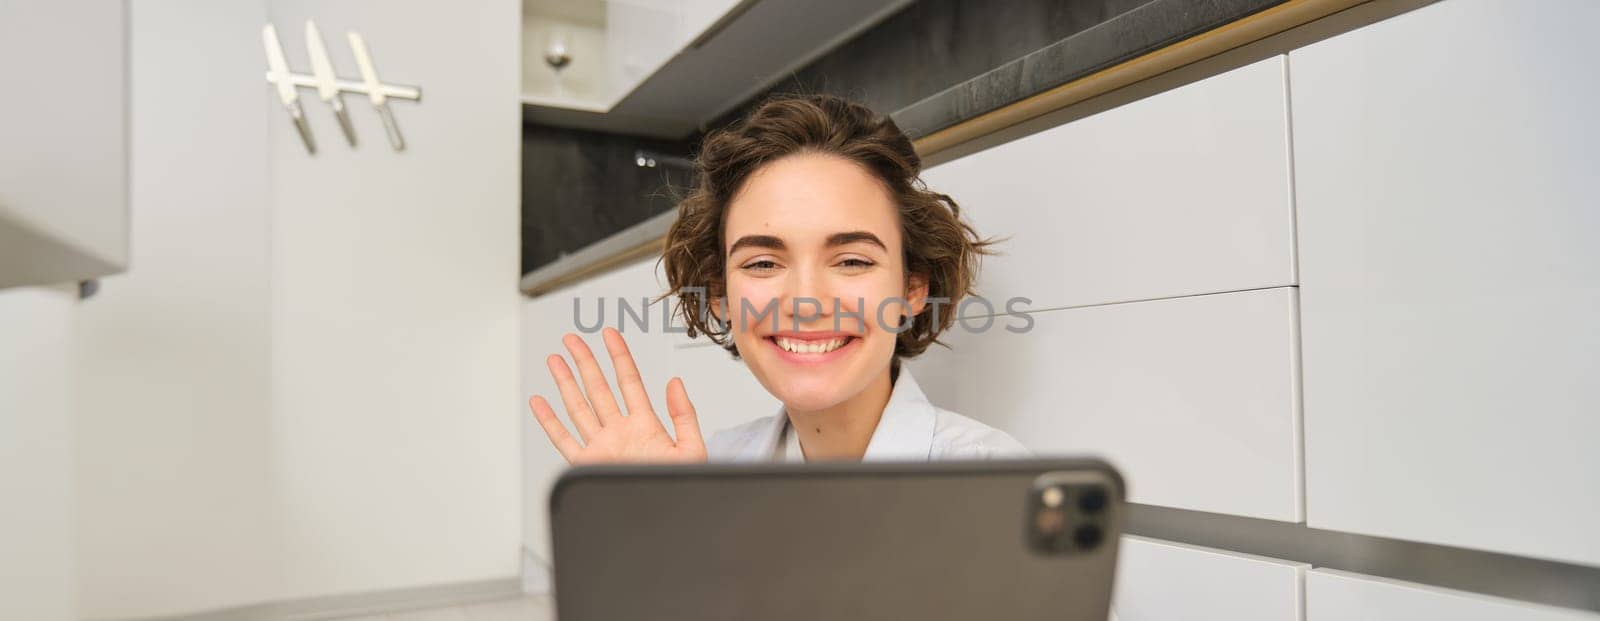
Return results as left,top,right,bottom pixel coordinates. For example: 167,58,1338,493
528,96,1027,464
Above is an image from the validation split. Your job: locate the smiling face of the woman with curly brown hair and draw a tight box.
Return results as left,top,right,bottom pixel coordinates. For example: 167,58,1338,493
723,154,926,411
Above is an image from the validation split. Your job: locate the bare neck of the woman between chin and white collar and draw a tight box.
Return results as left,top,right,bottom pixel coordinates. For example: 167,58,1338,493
784,368,894,461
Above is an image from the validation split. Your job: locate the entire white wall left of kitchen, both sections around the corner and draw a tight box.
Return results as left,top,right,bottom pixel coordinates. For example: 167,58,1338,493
77,0,522,618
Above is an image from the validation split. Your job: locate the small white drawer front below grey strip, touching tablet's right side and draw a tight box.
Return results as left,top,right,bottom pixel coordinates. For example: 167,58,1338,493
1114,535,1310,621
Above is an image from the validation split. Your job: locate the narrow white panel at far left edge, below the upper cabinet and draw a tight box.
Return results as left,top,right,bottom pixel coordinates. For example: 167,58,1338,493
0,286,77,619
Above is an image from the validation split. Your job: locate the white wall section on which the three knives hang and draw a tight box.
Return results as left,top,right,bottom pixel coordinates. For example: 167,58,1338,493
258,0,522,597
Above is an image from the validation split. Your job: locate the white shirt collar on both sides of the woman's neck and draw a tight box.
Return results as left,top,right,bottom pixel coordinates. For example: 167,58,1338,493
741,367,936,461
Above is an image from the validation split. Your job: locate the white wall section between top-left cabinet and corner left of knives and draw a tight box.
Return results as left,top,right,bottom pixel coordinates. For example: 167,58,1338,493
77,2,282,618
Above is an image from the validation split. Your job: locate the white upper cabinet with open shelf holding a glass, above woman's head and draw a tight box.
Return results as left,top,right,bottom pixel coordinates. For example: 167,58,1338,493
522,0,910,139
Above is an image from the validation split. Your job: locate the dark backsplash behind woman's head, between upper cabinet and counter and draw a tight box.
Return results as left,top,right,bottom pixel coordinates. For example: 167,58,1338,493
522,0,1149,274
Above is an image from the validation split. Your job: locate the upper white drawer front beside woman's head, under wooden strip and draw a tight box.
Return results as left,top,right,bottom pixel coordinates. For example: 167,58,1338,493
923,58,1294,313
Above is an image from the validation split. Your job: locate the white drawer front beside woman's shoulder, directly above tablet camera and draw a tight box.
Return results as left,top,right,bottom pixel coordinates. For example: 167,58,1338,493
910,288,1301,522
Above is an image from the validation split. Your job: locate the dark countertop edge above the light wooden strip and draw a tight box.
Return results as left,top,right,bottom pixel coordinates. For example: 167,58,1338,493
891,0,1286,138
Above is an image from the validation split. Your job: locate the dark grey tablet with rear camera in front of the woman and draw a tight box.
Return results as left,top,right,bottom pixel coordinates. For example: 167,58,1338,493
550,459,1125,621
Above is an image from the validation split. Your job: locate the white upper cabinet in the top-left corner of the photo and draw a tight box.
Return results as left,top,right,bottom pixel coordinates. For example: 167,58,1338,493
0,0,128,286
